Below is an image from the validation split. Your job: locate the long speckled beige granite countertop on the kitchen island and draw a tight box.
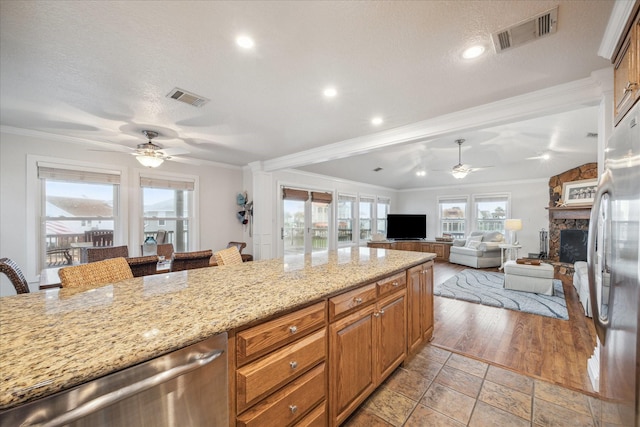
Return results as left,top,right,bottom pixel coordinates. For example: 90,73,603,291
0,248,435,409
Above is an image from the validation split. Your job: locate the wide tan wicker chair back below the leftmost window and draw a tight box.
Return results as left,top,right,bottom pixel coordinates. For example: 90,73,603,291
58,257,133,288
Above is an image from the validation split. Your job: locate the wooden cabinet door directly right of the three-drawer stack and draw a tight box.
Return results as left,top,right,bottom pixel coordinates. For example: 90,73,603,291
329,305,375,425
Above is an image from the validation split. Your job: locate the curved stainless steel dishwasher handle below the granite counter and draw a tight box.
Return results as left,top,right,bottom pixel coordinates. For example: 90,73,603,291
31,350,224,427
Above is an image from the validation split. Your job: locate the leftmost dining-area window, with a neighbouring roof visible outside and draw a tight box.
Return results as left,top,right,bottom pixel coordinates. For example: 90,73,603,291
37,162,120,268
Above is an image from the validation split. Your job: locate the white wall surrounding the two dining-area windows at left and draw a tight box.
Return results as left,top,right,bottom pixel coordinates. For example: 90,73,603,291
0,130,246,296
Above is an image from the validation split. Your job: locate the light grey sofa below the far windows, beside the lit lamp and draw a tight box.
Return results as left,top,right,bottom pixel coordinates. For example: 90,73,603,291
449,231,504,268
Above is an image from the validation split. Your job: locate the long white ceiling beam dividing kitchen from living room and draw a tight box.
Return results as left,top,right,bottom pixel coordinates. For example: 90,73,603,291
262,76,602,172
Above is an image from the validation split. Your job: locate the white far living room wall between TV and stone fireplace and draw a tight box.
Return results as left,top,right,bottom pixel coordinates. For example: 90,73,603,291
392,179,549,257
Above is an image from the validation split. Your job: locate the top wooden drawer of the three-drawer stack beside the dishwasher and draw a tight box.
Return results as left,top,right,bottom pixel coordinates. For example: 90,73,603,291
236,301,327,366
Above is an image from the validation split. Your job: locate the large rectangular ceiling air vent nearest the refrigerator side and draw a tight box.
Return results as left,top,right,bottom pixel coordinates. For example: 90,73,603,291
491,7,558,53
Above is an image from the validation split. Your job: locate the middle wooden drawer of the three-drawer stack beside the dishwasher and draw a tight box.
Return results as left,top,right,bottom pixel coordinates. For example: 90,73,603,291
236,329,327,412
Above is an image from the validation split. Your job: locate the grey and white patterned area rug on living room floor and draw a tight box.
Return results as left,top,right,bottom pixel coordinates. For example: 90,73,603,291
433,269,569,320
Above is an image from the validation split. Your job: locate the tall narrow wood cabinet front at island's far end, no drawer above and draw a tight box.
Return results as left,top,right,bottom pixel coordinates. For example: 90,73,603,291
407,261,434,352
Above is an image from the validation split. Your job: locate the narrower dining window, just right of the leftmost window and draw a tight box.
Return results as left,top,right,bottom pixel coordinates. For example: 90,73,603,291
140,176,195,252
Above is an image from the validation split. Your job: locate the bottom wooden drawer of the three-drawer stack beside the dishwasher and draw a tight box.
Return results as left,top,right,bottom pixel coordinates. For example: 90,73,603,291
237,363,325,427
